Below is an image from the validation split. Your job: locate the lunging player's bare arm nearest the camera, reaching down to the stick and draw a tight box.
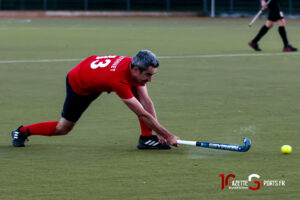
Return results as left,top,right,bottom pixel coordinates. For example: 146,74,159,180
123,97,179,146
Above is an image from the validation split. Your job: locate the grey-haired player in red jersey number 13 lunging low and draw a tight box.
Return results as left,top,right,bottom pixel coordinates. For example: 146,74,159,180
11,50,179,149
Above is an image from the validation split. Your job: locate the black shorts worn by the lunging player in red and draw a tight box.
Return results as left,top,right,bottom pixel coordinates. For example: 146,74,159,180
61,76,101,122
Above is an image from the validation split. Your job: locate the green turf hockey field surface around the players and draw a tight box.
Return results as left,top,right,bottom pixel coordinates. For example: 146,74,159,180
0,18,300,200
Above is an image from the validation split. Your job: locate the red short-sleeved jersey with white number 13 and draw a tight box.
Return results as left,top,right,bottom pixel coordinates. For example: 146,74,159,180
68,56,144,99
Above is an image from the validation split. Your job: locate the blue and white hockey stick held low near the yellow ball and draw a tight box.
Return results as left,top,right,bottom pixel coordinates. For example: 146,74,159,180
177,137,251,152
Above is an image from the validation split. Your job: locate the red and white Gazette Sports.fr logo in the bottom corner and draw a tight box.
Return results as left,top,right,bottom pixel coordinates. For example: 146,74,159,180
219,174,286,191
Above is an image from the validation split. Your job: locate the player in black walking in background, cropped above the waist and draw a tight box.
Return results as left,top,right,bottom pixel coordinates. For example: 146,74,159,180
248,0,298,52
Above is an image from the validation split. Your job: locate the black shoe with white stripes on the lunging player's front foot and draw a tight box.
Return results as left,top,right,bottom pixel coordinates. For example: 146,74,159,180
137,135,171,149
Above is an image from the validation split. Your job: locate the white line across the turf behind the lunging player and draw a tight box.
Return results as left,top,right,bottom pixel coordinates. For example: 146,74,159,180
0,52,300,64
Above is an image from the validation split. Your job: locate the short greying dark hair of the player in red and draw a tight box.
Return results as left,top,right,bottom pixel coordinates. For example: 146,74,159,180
131,50,159,71
